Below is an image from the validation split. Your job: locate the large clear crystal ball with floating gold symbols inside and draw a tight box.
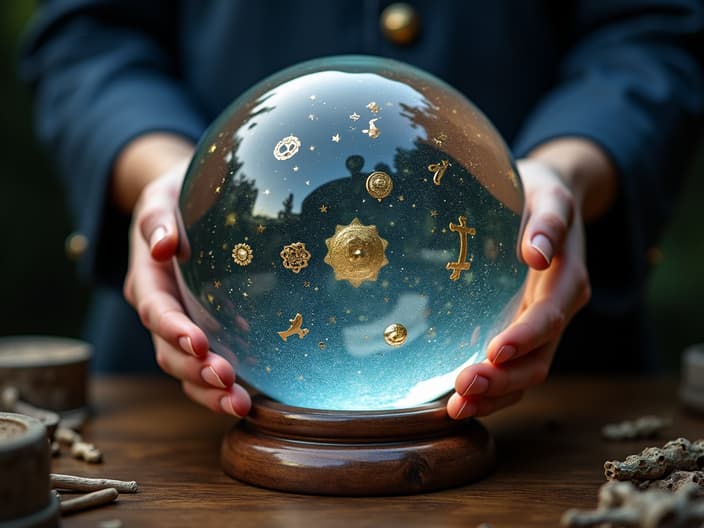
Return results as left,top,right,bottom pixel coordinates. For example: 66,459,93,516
175,55,527,410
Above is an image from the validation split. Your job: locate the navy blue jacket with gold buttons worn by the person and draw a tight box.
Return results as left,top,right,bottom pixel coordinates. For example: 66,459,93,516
21,0,704,370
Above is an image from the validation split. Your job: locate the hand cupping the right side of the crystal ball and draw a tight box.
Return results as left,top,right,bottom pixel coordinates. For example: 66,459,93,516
447,159,591,419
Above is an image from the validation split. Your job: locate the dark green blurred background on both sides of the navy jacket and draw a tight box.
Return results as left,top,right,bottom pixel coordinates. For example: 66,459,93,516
0,0,704,369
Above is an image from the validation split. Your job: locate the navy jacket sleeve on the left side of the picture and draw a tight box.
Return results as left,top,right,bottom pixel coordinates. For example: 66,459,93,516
20,0,205,282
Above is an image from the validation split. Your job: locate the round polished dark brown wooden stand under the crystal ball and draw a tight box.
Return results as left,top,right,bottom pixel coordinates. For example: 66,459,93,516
221,394,495,496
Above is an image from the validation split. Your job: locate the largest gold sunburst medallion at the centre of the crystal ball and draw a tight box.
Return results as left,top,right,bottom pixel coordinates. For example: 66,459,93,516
324,218,389,288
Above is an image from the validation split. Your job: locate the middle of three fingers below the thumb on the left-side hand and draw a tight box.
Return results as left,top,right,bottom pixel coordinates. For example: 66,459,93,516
154,336,235,389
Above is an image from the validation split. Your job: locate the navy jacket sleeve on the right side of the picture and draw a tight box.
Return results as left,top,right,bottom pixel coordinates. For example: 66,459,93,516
514,0,704,304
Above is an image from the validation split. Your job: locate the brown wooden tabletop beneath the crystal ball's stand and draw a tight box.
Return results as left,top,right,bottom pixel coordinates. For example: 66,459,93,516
52,376,704,528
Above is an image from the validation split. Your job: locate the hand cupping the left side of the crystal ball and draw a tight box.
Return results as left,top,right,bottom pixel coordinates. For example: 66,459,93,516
124,159,251,417
